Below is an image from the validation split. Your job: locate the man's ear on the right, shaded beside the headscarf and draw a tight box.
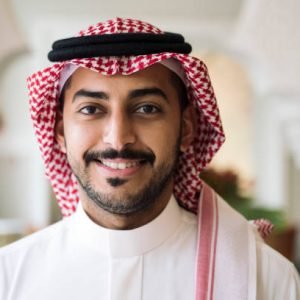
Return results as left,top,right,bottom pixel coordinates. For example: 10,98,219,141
180,105,196,152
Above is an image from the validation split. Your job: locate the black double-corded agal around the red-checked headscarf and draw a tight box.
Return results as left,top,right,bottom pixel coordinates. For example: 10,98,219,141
48,32,192,62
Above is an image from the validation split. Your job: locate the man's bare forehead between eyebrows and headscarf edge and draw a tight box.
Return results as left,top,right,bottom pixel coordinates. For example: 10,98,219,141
67,63,172,88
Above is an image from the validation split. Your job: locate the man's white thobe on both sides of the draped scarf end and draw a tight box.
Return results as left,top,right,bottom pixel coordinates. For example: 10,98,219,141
0,198,300,300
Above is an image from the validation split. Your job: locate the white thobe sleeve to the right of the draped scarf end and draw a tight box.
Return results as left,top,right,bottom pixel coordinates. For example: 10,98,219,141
257,241,300,300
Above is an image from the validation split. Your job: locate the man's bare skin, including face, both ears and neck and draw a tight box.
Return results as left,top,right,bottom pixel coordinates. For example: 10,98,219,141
56,64,194,229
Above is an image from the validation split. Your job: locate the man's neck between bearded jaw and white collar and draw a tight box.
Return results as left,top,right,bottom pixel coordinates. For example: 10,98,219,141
80,182,173,230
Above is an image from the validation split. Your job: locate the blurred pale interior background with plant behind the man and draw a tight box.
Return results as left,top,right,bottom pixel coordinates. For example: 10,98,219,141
0,0,300,263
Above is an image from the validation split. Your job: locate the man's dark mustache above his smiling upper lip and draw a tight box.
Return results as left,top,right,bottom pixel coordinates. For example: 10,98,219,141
83,148,156,166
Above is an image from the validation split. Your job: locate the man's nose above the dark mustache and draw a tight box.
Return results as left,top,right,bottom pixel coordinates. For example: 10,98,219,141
103,112,136,151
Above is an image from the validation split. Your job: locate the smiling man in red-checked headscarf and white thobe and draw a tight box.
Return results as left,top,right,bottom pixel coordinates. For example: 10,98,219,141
0,18,300,300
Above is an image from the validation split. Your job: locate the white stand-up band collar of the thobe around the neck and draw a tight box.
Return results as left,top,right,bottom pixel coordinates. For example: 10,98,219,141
69,196,181,257
